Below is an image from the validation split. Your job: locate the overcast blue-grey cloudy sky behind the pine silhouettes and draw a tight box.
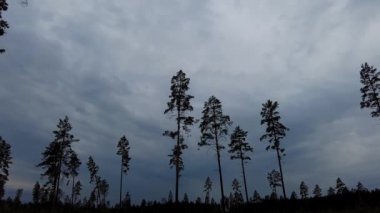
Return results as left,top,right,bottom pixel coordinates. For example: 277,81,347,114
0,0,380,206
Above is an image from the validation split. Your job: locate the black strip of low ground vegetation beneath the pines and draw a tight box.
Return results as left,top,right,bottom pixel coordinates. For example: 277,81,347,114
0,189,380,213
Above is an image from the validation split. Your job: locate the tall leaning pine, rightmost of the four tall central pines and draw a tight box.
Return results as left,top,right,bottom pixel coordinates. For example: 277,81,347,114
260,100,289,199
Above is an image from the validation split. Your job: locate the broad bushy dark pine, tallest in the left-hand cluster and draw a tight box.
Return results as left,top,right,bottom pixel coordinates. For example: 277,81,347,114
37,116,79,206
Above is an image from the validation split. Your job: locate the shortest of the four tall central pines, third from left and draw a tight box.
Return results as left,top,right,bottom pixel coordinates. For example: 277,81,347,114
228,126,253,202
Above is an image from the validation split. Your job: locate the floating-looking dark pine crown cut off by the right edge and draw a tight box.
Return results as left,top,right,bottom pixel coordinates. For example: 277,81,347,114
360,63,380,117
